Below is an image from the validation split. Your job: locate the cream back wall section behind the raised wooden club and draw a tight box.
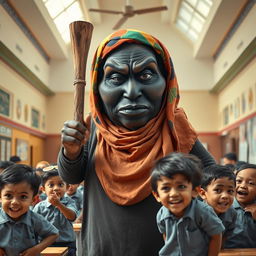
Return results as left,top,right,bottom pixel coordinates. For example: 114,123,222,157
46,92,89,134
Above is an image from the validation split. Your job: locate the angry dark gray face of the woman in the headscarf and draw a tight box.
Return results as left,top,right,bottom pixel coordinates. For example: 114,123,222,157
99,45,166,130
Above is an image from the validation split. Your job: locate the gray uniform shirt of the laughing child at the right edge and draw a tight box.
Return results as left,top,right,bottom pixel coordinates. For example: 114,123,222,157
224,199,256,248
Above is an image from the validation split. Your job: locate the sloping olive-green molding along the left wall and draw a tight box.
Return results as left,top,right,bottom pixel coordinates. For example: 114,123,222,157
0,41,55,96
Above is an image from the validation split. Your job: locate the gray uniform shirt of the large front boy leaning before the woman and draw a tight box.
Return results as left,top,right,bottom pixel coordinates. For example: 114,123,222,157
156,199,225,256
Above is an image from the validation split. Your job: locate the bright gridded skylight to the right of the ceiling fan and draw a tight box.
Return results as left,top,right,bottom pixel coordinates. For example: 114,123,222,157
176,0,212,41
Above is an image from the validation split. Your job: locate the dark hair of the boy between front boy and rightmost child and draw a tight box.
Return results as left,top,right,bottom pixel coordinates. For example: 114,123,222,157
201,164,236,190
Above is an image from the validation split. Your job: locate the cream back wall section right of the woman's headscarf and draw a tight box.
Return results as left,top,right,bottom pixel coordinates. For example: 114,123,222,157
179,91,218,133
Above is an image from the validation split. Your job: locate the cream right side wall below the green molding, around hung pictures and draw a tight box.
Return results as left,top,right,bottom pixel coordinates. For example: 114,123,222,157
218,58,256,130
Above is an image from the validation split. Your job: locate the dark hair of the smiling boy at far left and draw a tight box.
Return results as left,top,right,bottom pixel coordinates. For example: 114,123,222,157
0,164,41,196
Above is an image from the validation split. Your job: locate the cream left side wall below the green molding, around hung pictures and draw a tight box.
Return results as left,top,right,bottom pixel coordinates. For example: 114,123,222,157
0,61,47,132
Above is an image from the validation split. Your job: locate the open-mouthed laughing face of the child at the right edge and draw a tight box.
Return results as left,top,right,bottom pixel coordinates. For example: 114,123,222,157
236,168,256,206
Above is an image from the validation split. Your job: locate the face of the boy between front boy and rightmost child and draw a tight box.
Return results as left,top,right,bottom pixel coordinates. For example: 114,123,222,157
200,177,235,214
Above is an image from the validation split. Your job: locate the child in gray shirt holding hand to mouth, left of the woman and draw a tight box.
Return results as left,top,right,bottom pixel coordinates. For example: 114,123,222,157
33,165,77,256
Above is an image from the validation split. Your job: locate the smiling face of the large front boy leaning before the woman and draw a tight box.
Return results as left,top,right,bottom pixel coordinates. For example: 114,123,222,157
153,174,196,217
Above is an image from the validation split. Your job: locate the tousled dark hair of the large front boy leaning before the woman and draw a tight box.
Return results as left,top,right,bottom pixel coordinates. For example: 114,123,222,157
151,153,202,192
